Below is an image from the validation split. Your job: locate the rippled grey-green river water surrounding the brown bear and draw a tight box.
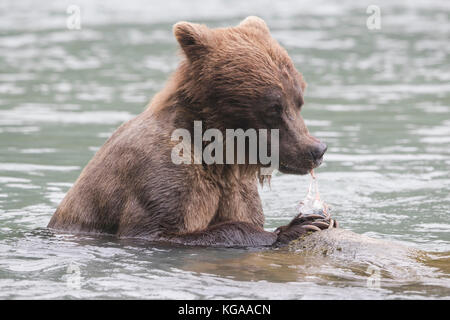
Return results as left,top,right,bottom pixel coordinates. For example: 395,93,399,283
0,0,450,299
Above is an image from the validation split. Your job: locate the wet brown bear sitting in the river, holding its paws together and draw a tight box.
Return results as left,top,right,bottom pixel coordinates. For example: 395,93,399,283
48,17,333,246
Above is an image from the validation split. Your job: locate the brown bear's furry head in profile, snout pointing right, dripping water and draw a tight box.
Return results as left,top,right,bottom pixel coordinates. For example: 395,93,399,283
174,17,327,174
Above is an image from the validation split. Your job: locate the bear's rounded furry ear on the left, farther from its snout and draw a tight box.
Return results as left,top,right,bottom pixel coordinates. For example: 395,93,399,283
173,21,209,59
